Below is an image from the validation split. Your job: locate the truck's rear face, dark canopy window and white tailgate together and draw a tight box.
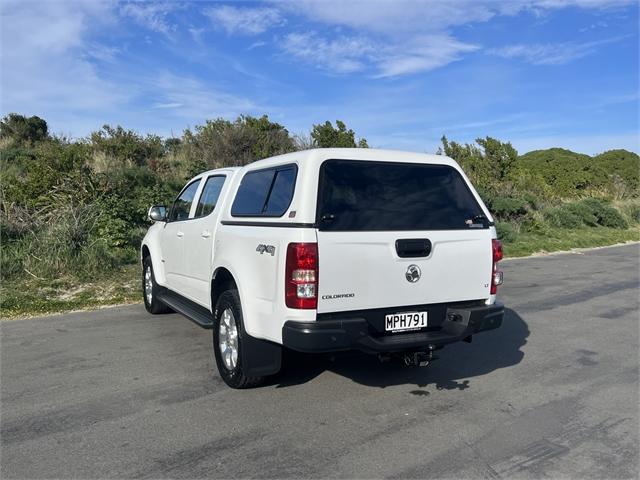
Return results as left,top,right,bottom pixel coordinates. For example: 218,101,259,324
316,160,493,313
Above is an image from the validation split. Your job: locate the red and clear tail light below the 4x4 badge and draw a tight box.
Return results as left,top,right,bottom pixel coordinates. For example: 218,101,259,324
285,243,318,309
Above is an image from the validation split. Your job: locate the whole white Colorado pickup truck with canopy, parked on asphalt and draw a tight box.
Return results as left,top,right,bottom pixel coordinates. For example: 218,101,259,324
141,149,504,388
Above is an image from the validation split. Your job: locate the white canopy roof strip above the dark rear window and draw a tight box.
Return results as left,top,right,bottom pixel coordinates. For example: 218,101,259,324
238,148,455,170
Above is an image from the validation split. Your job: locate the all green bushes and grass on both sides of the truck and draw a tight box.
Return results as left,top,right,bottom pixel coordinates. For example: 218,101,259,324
0,114,640,317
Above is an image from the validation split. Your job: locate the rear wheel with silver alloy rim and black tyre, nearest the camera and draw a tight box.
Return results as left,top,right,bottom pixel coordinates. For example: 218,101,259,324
213,289,265,388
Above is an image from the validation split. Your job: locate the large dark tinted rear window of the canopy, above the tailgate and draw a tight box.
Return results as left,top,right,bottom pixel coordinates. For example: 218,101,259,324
317,160,484,231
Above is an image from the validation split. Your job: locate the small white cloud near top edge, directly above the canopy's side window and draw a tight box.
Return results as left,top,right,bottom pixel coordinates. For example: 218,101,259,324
204,5,285,35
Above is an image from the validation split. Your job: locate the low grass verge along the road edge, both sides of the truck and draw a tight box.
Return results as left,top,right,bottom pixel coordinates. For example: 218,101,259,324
0,226,640,319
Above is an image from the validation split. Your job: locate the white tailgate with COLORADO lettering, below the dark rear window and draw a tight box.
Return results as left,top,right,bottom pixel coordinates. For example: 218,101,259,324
318,229,492,313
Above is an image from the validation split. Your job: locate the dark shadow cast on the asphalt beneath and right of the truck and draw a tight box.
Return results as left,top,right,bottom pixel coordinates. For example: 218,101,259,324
270,308,529,390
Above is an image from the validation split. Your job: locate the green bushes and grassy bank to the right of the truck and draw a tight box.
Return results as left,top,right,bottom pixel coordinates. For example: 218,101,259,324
441,137,640,256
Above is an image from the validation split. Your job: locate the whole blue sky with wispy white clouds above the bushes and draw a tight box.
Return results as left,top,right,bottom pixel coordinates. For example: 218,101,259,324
0,0,640,154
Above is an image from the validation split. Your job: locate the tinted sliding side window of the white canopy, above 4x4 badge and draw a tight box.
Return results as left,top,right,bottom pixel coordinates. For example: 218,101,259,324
231,165,298,217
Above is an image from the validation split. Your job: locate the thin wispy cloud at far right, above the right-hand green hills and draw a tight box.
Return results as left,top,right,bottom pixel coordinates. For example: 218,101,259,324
489,37,625,65
